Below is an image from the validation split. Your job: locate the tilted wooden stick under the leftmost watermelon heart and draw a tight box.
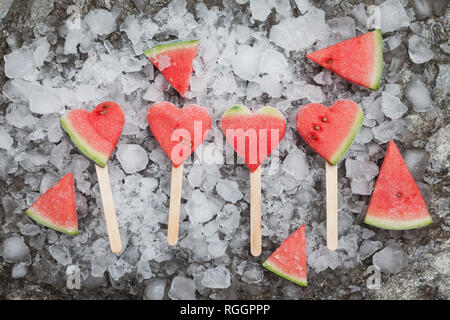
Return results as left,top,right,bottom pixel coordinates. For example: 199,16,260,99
95,165,122,253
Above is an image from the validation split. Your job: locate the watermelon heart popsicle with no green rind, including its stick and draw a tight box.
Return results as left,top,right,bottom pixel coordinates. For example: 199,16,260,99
147,101,211,246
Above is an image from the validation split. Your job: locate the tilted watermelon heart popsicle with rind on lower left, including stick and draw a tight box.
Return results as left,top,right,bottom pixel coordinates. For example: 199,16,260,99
60,101,125,253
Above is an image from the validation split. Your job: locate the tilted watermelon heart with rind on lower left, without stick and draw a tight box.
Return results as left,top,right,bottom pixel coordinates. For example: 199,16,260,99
60,101,125,167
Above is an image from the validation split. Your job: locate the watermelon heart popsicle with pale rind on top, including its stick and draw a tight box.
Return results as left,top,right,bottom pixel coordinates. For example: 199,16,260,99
222,105,286,256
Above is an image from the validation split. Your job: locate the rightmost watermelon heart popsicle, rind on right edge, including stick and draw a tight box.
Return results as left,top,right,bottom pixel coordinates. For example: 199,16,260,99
296,100,364,250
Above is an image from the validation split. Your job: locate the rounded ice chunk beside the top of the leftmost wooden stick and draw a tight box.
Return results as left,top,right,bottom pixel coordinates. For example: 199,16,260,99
116,144,148,173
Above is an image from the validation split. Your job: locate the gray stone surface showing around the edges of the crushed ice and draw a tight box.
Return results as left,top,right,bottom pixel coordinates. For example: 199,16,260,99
0,0,450,300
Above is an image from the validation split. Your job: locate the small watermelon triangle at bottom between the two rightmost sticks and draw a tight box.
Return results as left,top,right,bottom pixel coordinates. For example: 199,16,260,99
263,225,307,287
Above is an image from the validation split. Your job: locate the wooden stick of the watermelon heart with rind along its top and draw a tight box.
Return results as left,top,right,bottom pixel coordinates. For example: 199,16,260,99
250,166,261,257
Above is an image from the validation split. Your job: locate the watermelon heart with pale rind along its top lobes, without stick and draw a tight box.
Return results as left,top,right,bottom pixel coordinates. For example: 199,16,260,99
222,105,286,172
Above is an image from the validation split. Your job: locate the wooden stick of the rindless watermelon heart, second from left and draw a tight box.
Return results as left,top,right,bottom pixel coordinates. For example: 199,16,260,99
167,163,183,246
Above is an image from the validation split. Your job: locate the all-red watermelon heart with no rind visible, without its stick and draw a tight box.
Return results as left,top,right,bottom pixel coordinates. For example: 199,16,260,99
147,101,211,167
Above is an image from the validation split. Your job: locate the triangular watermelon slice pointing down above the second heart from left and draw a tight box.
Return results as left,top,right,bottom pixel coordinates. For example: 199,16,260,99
144,40,198,98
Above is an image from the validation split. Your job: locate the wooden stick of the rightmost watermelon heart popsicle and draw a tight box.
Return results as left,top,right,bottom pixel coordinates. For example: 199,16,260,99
325,161,338,251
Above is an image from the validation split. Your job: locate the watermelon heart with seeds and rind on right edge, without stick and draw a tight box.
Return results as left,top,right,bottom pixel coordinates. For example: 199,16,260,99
297,100,364,165
